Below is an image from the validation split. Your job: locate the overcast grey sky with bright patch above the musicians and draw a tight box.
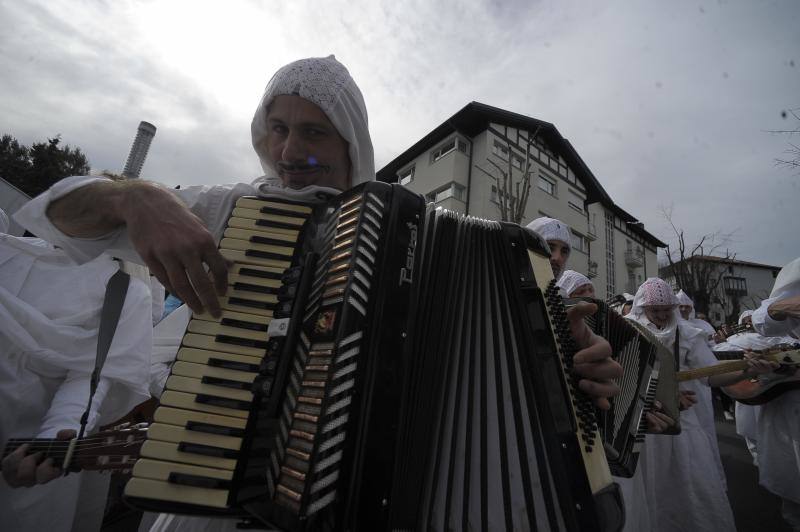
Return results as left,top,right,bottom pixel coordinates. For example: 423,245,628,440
0,0,800,265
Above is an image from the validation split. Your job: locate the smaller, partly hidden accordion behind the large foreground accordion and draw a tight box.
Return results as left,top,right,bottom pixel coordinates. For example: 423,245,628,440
564,298,680,478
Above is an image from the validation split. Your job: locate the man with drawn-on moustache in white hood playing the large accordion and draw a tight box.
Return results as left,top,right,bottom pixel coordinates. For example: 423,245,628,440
15,56,622,530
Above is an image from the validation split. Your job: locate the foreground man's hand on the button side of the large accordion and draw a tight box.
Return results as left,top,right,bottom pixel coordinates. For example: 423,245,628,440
567,301,622,410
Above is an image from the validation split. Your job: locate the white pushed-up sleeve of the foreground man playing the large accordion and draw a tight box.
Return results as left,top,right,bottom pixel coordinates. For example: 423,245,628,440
14,176,256,264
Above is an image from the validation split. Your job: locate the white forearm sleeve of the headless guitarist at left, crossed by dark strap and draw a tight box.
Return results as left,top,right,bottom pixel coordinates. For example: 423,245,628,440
37,372,111,438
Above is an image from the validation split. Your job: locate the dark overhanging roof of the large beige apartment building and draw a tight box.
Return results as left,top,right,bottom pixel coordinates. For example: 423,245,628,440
377,102,667,247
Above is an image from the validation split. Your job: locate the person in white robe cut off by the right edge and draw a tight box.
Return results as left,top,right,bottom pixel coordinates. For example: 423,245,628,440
752,258,800,530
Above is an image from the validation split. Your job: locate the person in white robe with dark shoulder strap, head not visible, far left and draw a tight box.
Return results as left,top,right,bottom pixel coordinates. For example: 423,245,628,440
0,215,152,532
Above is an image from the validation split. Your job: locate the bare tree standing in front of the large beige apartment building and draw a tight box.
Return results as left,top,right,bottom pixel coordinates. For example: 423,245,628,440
475,128,539,224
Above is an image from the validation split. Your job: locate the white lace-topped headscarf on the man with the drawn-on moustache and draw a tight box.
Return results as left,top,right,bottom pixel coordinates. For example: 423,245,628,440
250,55,375,192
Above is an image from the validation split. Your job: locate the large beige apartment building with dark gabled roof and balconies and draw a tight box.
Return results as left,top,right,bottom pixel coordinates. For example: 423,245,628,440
377,102,666,297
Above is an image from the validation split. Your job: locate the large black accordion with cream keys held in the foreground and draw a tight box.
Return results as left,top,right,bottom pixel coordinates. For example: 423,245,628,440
125,183,623,531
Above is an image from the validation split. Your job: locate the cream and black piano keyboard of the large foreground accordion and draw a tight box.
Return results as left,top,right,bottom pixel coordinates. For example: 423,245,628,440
125,198,311,513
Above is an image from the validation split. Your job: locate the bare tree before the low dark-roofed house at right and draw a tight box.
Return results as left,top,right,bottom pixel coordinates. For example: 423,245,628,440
659,207,740,315
